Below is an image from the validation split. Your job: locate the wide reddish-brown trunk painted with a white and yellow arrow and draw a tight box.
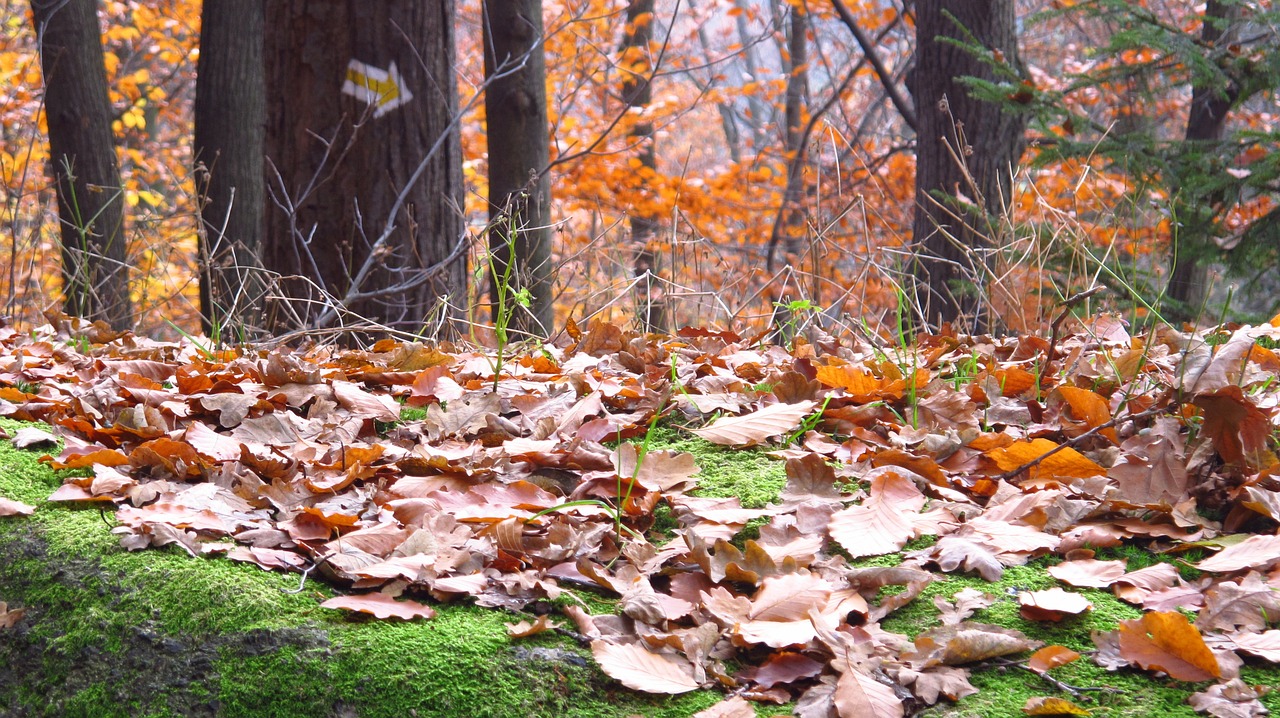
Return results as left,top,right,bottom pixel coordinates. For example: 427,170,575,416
262,0,467,331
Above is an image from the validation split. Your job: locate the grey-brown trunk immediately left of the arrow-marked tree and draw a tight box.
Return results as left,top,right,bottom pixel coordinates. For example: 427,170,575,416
195,0,266,339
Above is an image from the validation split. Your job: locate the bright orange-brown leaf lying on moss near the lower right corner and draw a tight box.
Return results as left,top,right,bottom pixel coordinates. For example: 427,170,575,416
1117,610,1222,682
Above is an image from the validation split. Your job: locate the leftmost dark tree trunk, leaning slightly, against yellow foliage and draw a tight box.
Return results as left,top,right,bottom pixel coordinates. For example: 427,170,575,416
31,0,133,329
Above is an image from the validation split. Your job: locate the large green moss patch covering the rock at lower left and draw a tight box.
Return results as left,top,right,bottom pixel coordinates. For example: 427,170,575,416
0,421,742,718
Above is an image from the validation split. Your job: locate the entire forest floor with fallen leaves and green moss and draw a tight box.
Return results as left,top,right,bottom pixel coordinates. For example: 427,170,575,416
0,319,1280,718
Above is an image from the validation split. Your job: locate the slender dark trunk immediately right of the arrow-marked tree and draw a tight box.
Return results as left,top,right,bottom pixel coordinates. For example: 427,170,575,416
484,0,554,337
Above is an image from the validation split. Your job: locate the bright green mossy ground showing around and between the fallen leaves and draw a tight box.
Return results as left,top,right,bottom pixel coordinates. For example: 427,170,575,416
0,420,1280,718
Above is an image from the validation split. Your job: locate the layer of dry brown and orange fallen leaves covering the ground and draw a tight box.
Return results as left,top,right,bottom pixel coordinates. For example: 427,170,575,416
0,311,1280,717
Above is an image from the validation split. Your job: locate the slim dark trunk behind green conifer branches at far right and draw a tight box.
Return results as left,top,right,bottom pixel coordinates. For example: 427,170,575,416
1166,0,1240,320
